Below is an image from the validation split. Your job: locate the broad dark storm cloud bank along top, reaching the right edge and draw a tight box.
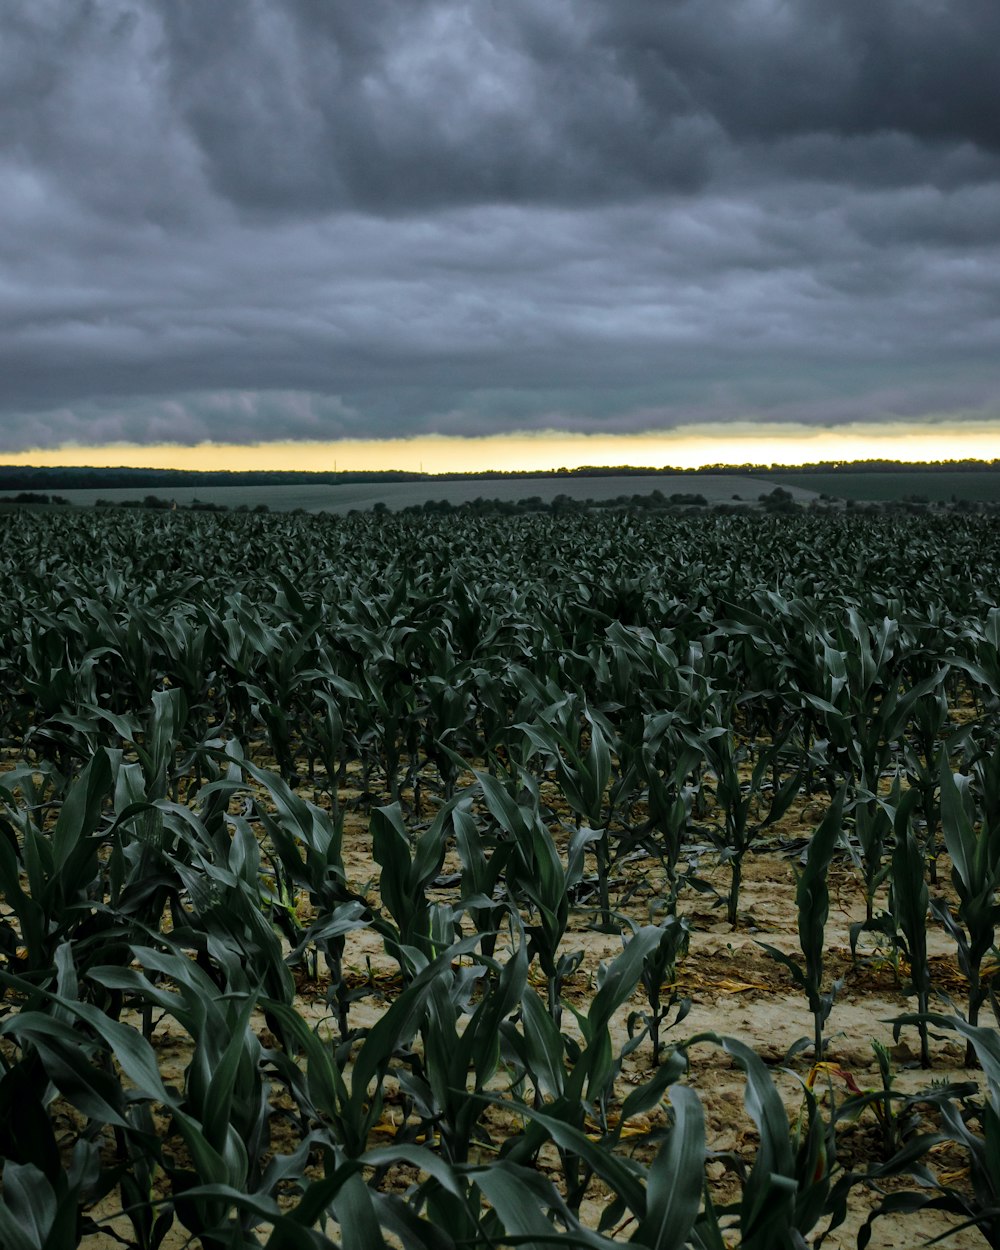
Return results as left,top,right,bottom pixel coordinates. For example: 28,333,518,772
150,0,1000,213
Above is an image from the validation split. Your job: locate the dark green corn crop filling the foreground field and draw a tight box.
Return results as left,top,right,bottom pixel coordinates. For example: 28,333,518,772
0,511,1000,1250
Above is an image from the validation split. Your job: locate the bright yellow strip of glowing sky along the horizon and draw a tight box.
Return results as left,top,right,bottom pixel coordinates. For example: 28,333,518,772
0,419,1000,474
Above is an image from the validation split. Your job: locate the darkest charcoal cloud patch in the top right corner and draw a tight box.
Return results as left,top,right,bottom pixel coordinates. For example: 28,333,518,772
601,0,1000,153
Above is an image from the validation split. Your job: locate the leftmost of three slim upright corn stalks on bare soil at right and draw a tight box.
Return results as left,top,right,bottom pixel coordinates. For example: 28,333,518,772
758,789,844,1063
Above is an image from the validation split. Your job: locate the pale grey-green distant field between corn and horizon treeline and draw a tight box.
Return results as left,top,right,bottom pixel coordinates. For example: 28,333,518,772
59,474,824,514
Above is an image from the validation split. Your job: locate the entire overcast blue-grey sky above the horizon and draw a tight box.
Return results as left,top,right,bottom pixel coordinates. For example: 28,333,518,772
0,0,1000,468
